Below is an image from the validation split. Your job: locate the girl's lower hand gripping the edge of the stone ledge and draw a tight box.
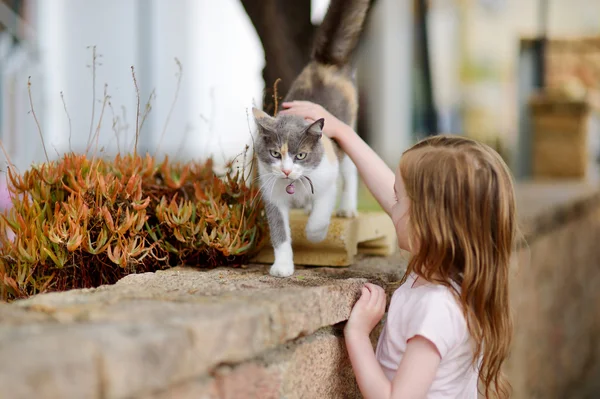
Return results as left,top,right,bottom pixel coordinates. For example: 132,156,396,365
344,283,386,336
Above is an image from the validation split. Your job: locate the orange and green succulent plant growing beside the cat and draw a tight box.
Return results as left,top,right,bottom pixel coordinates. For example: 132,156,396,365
0,153,268,301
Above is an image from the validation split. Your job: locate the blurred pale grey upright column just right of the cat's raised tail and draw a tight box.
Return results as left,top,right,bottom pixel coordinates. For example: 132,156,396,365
358,0,414,167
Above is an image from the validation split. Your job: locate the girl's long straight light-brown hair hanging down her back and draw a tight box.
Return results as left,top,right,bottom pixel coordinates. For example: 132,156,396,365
399,136,517,398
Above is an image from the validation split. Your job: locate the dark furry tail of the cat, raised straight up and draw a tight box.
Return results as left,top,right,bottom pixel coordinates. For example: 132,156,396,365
312,0,371,66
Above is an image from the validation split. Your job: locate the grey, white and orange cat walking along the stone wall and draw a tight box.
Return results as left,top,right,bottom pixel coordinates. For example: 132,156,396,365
252,0,370,277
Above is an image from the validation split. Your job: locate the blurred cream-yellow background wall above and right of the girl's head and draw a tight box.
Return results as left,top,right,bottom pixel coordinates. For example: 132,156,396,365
428,0,600,167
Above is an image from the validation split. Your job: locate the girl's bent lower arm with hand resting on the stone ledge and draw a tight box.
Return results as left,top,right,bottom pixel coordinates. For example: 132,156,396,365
344,284,441,399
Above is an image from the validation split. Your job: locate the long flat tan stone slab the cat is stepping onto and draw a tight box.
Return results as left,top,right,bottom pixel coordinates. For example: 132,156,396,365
0,256,402,399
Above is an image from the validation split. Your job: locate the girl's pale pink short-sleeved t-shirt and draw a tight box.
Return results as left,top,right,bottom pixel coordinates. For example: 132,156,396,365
375,274,478,399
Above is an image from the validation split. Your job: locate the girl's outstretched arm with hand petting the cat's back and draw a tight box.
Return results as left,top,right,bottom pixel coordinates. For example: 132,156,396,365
280,101,395,215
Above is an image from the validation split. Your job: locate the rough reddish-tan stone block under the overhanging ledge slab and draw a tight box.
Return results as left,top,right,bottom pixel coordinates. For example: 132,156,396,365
145,328,361,399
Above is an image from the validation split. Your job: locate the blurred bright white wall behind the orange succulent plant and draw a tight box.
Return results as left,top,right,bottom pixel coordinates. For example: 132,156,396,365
2,0,263,172
